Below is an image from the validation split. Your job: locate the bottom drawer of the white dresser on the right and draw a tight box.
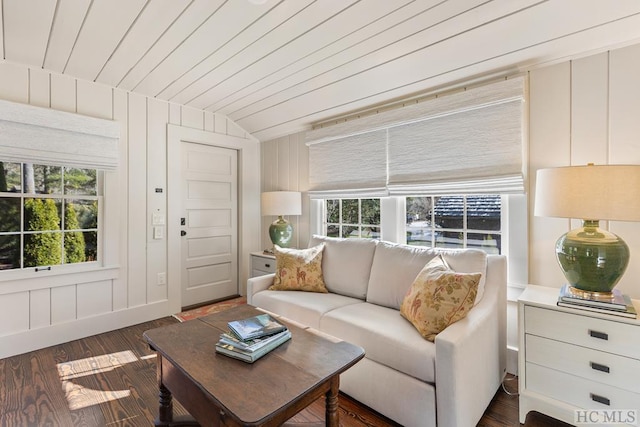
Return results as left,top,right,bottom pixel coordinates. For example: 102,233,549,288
526,363,640,410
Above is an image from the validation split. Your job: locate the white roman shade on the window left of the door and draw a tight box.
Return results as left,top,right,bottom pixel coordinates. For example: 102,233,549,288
0,100,120,170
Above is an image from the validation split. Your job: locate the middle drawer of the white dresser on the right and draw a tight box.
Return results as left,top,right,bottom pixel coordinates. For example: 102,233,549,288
525,335,640,393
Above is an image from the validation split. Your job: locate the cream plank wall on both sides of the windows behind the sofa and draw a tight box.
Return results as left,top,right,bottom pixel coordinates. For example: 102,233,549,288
262,41,640,373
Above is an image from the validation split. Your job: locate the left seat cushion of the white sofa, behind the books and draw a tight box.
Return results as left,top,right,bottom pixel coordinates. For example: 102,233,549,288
251,290,362,329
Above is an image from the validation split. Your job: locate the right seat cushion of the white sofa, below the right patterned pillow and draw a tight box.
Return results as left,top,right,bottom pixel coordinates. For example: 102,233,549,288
320,302,436,384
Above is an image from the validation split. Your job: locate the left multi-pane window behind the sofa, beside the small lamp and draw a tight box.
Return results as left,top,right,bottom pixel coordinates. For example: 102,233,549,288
323,199,380,239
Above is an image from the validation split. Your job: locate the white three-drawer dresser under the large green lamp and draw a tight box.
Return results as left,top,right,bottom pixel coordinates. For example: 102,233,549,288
518,285,640,425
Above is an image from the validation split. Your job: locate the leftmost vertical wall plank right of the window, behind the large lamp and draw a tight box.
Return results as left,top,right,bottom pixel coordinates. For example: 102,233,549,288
528,62,571,287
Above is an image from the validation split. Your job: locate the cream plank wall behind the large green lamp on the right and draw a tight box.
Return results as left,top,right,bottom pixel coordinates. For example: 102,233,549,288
529,45,640,298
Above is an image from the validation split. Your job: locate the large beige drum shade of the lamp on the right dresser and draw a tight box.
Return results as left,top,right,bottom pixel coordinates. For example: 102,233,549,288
534,165,640,221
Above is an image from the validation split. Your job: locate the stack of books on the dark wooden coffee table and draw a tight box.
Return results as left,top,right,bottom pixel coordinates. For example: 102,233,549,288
216,313,291,363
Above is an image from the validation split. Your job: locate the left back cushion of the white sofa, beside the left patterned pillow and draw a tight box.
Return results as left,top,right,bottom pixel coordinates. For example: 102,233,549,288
309,235,377,300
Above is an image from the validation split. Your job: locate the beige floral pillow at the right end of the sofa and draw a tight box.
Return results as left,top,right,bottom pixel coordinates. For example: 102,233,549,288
400,255,482,341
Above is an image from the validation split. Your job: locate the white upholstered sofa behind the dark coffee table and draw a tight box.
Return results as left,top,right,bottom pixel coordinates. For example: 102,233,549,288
247,236,507,427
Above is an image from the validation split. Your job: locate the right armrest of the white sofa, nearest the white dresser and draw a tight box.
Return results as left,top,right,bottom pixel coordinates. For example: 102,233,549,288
435,256,507,427
